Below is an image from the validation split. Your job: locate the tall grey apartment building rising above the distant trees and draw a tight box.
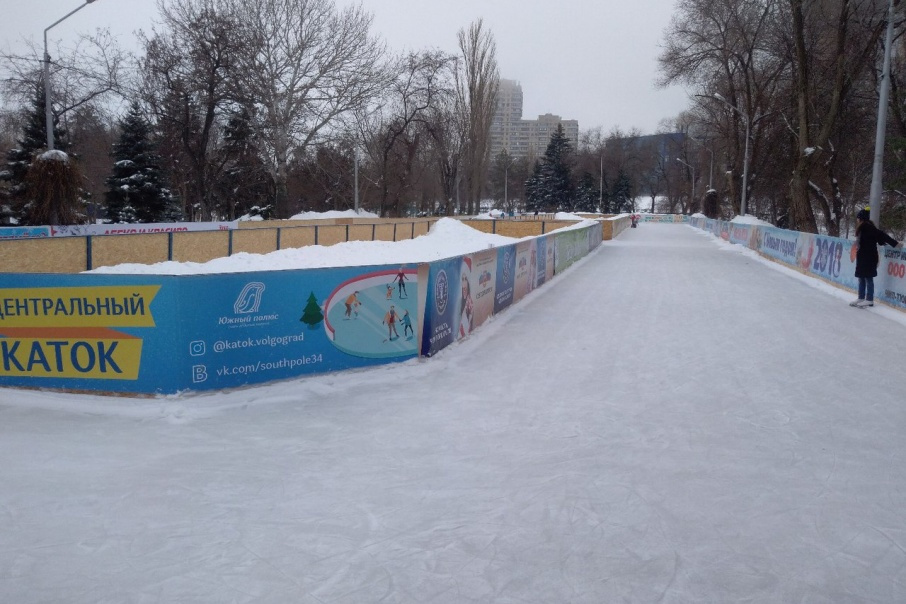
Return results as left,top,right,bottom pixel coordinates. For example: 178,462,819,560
491,79,579,159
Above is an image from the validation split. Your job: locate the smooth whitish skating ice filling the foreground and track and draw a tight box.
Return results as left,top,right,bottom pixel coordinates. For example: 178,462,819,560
0,224,906,604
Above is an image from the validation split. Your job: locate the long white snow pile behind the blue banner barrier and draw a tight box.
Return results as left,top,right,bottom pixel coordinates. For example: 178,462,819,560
87,218,520,275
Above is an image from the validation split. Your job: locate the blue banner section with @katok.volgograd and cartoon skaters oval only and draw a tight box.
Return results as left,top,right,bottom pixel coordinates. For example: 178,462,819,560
177,265,418,390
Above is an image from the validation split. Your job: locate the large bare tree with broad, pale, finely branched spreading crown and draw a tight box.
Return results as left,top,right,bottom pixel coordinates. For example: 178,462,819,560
225,0,385,216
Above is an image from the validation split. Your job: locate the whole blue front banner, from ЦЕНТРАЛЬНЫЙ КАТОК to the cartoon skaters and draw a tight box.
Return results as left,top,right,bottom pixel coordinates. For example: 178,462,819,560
0,265,419,393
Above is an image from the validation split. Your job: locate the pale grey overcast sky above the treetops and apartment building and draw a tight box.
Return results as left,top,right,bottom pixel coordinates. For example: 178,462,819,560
0,0,687,133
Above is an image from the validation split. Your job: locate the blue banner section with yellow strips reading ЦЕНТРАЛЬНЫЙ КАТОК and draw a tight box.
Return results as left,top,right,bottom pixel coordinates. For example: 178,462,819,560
0,274,180,392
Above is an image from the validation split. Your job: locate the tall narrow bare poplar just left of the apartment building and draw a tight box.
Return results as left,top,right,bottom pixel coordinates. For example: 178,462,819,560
457,19,500,214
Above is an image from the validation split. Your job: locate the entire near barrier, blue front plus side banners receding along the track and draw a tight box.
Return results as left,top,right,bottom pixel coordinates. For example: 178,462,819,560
0,224,604,395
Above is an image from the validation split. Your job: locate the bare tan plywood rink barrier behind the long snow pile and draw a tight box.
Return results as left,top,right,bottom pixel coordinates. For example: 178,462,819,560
0,214,628,274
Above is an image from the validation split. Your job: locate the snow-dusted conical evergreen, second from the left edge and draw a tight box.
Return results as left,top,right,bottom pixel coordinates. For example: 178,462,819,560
104,102,181,222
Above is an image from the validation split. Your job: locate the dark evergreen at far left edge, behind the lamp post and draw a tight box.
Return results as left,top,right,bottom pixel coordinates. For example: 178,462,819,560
0,84,69,224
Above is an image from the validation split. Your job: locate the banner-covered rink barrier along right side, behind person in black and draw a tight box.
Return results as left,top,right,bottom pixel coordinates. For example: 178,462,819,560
689,217,906,310
